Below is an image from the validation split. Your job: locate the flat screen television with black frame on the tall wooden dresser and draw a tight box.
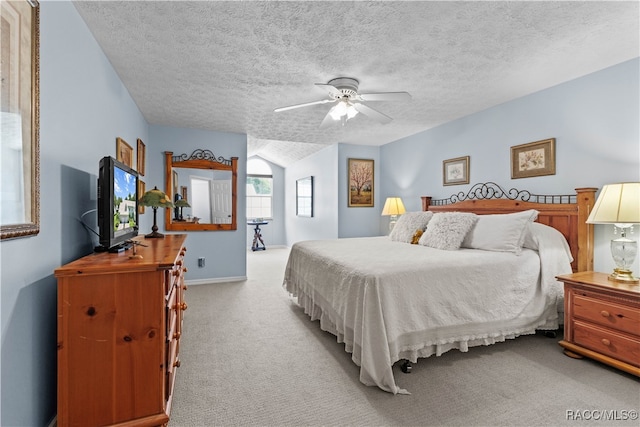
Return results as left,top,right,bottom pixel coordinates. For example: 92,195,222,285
96,156,138,252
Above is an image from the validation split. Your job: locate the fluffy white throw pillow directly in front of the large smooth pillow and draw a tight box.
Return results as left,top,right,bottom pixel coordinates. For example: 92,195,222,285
418,212,477,251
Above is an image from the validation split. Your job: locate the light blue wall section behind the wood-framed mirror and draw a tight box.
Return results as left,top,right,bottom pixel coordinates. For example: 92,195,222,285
150,125,247,283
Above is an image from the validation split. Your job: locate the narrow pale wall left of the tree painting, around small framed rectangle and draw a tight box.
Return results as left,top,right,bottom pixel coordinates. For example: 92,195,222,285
284,145,339,246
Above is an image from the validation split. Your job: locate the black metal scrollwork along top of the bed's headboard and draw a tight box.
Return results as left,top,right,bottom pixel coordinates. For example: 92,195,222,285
431,182,576,206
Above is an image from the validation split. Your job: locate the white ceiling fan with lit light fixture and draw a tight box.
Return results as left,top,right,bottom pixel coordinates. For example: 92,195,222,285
273,77,411,127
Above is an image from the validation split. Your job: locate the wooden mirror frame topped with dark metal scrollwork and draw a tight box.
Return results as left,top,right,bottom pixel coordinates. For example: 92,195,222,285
164,149,238,231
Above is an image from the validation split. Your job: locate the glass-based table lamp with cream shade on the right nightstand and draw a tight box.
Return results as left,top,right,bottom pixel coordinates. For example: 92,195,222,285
587,182,640,283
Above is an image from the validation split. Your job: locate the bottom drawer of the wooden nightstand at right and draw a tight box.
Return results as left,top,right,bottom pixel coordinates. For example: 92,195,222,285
573,321,640,366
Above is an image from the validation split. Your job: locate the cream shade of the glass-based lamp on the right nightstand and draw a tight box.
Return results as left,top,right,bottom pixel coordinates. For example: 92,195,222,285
587,182,640,224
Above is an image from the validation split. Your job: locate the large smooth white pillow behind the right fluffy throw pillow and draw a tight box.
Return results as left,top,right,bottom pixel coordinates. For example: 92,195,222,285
462,209,538,254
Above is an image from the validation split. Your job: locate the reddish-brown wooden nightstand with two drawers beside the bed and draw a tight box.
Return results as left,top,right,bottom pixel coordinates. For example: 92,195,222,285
558,271,640,376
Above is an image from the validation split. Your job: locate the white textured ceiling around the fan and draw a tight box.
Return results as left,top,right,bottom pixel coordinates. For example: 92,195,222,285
74,1,640,166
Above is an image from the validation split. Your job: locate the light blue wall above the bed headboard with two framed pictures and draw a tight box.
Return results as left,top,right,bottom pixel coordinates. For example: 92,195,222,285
379,59,640,273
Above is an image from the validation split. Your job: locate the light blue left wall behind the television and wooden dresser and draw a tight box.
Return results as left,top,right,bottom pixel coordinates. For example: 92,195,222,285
0,2,148,426
